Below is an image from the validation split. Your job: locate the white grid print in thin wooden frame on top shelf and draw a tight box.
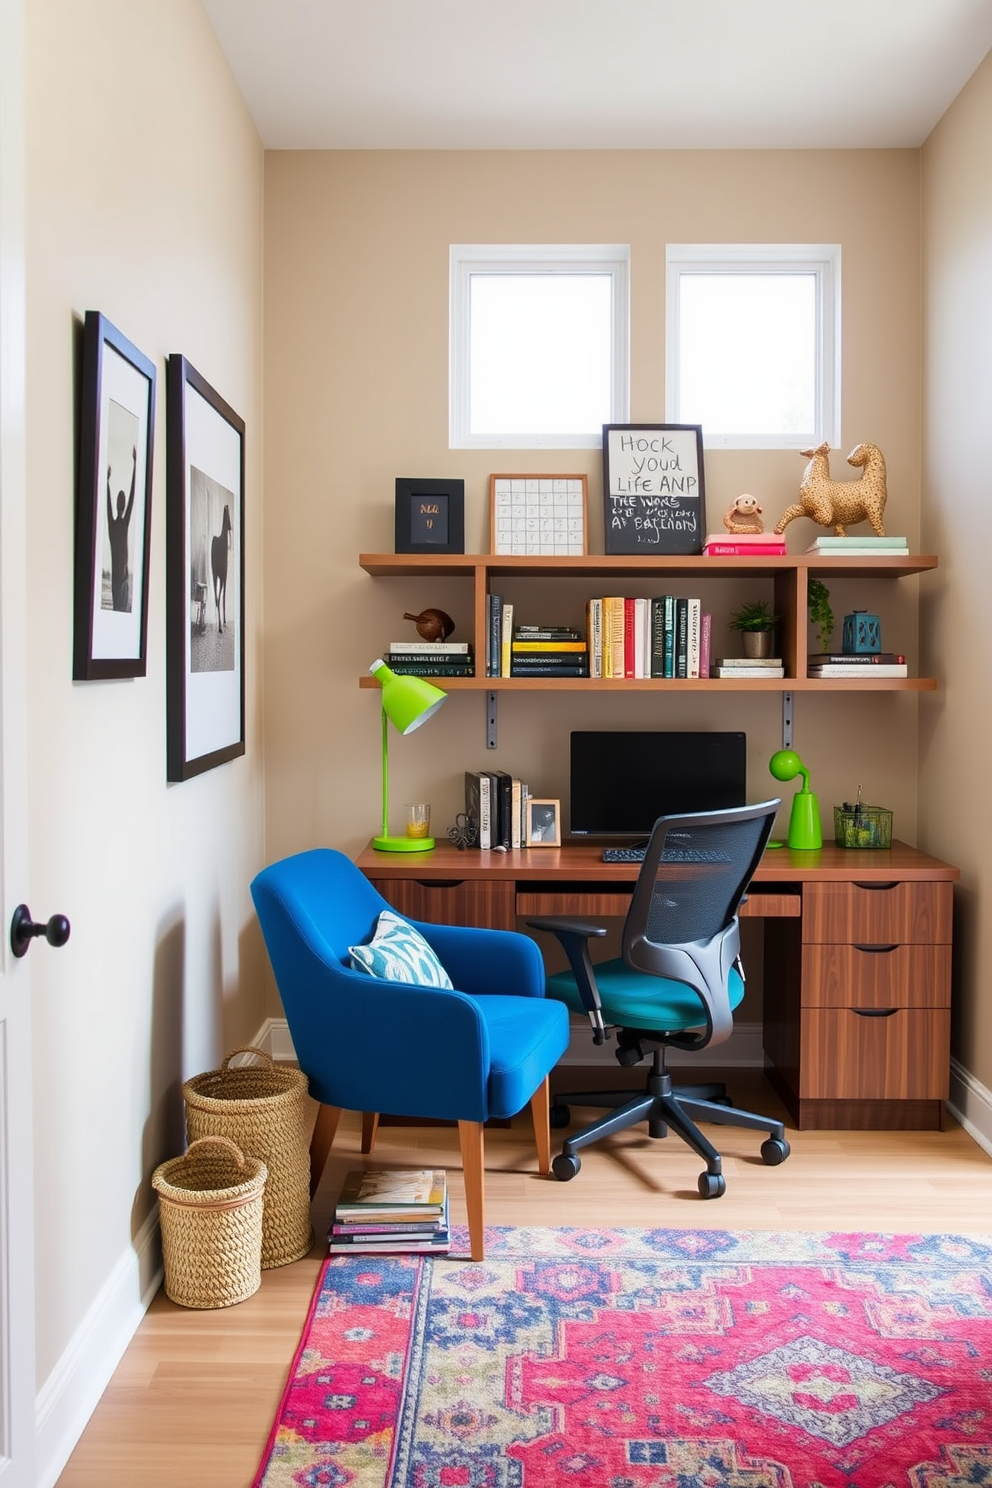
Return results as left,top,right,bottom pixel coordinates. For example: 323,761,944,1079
489,475,589,558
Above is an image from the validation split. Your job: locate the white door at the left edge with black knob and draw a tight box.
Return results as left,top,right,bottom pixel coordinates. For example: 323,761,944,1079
0,0,37,1488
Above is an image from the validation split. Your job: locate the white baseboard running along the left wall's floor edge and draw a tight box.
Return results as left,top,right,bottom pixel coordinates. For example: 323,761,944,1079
34,1207,162,1488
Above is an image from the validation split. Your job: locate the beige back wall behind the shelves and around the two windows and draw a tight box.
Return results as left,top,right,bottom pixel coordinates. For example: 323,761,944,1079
265,150,921,958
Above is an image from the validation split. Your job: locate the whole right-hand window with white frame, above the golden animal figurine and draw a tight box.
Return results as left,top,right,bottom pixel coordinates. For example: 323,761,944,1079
666,243,840,449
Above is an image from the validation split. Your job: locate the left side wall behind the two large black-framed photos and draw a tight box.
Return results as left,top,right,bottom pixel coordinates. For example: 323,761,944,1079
25,0,263,1384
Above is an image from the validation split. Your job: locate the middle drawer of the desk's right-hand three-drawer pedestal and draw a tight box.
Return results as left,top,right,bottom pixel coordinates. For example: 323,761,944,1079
803,942,950,1007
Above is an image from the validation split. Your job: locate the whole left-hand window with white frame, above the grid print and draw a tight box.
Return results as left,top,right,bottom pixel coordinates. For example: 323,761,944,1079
449,244,629,449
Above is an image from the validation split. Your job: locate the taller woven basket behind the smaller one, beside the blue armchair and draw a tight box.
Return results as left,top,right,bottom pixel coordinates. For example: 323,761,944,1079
183,1045,314,1271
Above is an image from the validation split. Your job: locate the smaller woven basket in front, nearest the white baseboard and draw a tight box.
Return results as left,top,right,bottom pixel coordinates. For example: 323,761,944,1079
152,1137,265,1308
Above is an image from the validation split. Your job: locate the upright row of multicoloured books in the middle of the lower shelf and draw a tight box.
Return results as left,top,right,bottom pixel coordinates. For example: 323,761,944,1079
586,594,712,679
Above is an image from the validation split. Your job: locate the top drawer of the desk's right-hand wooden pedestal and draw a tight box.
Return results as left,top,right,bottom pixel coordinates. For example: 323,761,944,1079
803,882,953,945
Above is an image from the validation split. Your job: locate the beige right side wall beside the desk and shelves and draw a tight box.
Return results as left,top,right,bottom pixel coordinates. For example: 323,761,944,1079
919,57,992,1091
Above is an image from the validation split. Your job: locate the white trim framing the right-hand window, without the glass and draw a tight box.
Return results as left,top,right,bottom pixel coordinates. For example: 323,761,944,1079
665,243,840,449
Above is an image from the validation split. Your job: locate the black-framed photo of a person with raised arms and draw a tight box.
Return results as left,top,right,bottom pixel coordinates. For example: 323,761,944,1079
73,319,155,682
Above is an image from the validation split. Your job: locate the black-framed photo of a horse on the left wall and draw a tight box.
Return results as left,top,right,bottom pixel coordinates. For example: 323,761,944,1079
165,356,245,780
